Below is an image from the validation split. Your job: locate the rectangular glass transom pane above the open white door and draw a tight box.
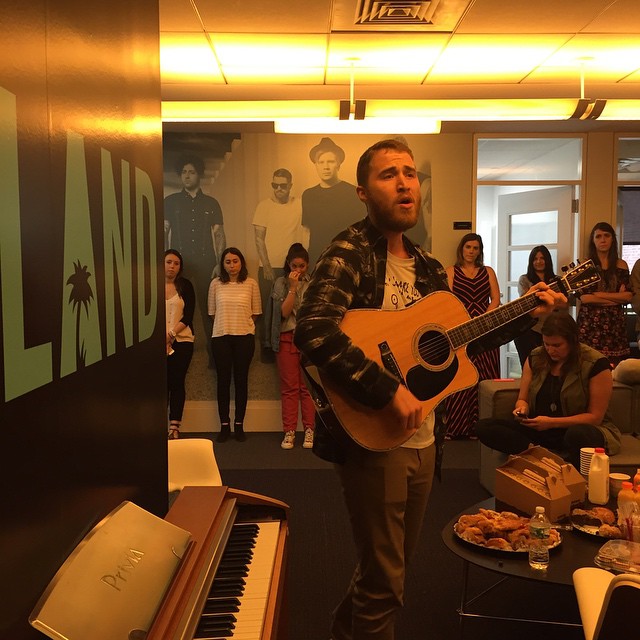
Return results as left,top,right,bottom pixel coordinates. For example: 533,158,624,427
477,138,582,182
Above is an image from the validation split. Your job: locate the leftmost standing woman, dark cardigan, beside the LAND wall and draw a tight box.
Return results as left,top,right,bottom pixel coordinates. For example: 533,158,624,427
164,249,196,440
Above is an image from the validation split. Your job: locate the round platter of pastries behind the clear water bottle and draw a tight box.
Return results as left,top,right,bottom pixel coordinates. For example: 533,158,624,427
453,509,562,553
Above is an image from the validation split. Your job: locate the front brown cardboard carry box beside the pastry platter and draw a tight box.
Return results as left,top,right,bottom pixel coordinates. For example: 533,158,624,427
495,456,571,522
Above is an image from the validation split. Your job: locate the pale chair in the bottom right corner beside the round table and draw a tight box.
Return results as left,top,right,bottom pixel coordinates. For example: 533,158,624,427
573,567,640,640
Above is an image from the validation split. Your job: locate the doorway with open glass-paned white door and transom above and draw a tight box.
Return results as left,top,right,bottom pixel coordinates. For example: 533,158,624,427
475,135,584,378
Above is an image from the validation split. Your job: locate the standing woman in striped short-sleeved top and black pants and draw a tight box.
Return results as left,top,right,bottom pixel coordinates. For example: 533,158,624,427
209,247,262,442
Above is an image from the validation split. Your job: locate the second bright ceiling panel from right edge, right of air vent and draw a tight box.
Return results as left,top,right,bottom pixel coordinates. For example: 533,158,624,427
426,35,567,84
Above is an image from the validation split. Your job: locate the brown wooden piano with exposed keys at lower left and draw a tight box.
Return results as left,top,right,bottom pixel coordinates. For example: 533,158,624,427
29,487,288,640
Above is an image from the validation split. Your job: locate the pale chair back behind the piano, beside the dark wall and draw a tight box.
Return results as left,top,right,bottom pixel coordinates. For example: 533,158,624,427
167,438,222,492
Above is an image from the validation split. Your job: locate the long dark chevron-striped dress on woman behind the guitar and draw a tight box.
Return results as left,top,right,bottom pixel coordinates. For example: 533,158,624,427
445,266,500,438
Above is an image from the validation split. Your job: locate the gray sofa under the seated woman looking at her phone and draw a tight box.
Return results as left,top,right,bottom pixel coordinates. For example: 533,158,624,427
478,380,640,494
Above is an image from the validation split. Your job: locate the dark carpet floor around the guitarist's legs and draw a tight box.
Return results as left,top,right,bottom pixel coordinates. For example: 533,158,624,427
178,432,583,640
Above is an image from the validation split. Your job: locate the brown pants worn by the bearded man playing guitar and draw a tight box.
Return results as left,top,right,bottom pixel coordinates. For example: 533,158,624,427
331,445,435,640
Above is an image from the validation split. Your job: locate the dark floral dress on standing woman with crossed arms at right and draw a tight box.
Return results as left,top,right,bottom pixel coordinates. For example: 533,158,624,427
577,267,631,363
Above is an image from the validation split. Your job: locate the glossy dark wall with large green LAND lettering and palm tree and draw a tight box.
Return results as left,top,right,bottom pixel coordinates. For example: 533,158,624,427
0,0,167,640
